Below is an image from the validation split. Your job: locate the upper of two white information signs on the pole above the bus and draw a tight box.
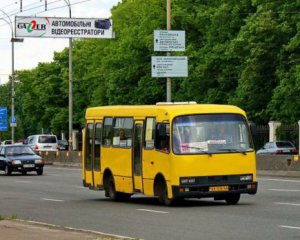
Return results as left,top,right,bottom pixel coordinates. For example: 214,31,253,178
154,30,185,52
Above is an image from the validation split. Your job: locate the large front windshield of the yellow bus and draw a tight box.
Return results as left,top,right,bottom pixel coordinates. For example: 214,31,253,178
172,114,253,154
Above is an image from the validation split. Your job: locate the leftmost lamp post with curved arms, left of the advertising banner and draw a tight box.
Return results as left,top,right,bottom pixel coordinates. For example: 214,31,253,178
0,9,24,141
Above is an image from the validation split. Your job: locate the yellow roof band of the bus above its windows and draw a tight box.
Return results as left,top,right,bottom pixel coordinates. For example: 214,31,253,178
86,103,246,120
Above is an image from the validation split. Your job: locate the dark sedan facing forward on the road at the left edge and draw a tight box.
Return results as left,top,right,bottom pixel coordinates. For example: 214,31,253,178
0,145,45,175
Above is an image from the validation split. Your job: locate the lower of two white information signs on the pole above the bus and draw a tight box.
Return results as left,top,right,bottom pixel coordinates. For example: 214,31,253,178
151,56,188,77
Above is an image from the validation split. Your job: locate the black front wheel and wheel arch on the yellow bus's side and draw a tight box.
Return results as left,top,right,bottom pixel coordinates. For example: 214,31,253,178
154,173,174,206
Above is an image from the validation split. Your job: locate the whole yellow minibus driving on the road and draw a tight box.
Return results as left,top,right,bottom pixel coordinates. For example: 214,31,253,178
82,102,257,205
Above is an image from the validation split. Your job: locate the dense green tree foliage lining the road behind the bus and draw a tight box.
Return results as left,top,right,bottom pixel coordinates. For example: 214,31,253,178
0,0,300,138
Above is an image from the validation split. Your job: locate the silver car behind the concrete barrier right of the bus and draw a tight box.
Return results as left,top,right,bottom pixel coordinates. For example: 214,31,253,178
256,141,298,154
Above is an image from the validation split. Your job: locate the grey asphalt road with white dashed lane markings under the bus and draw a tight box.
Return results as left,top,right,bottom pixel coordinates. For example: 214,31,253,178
0,166,300,240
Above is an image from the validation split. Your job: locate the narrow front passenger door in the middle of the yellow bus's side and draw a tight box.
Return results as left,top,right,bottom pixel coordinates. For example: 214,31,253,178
132,121,143,192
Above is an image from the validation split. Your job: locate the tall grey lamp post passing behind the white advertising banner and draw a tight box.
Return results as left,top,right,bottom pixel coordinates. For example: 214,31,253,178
64,0,73,151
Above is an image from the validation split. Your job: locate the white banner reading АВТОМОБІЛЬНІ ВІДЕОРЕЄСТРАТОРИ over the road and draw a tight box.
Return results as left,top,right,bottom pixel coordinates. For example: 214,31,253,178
15,17,113,38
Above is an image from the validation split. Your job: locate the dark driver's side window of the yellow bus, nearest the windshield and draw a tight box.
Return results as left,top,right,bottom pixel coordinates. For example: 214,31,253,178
154,123,170,153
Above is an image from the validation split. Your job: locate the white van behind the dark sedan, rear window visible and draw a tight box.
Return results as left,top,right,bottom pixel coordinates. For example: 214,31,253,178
25,134,58,152
